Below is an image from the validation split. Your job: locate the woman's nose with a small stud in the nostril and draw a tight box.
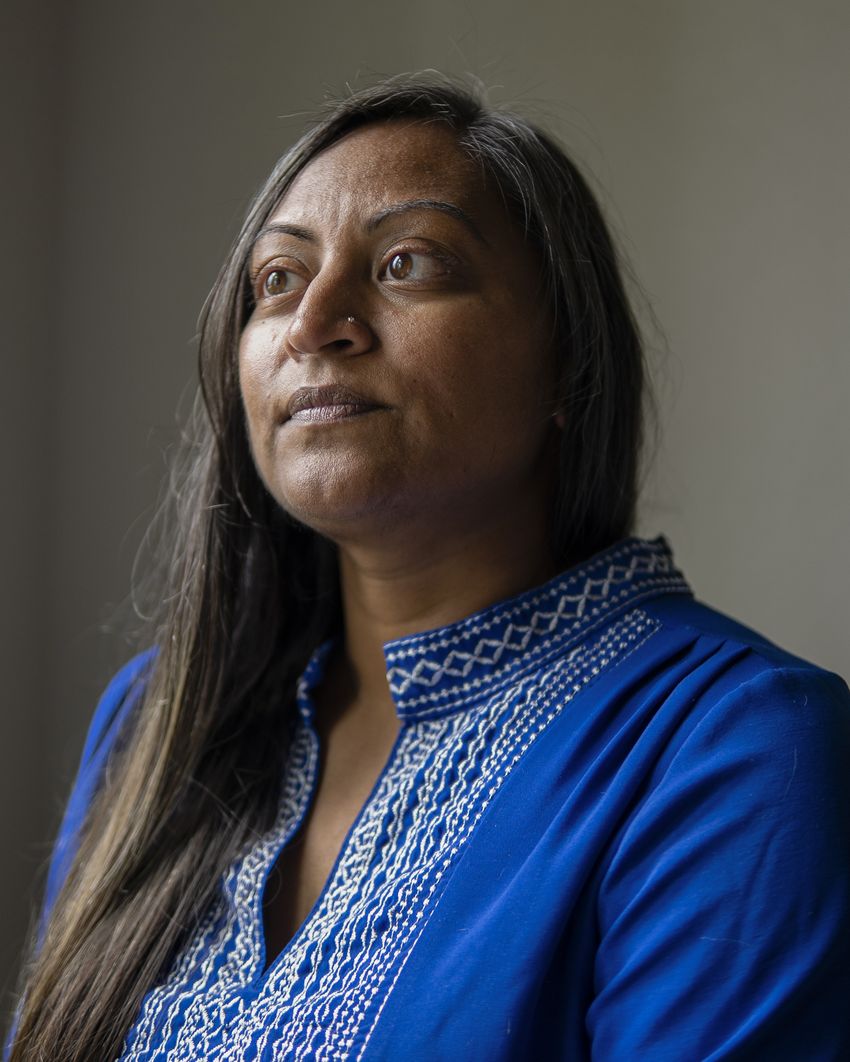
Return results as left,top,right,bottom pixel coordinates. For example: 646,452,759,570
286,267,374,361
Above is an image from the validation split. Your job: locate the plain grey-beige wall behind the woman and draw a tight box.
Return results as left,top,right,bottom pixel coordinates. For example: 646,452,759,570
0,0,850,1028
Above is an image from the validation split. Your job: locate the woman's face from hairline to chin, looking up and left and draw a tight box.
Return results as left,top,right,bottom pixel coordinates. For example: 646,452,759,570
239,122,556,543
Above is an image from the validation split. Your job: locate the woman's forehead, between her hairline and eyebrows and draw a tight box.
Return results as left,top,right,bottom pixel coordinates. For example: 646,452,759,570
271,121,497,223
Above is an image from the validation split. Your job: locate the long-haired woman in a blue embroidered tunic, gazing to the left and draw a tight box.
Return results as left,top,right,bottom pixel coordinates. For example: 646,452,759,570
11,75,850,1062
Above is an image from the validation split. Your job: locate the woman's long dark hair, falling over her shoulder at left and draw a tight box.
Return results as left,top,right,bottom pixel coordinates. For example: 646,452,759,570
11,74,644,1062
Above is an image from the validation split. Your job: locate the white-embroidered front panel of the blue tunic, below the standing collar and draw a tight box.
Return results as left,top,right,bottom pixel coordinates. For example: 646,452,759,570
124,611,657,1060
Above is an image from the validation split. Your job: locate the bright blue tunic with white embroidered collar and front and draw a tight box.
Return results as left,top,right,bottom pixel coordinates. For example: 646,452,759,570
19,538,850,1062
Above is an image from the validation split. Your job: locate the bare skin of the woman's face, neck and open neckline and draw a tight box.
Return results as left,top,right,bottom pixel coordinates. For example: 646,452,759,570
239,121,558,959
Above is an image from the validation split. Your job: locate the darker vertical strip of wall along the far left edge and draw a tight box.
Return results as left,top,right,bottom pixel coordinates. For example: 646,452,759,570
0,3,64,1028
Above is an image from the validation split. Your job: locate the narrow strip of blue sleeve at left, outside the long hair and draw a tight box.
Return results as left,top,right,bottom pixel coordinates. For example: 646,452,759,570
38,648,156,945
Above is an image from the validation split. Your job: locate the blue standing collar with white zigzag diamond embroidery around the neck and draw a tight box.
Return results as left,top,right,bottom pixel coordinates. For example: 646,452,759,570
299,537,691,722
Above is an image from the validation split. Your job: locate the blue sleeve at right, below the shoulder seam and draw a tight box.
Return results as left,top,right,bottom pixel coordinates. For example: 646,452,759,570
588,668,850,1062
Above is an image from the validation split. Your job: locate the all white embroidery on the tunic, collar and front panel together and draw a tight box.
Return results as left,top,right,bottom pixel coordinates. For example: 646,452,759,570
121,541,684,1062
